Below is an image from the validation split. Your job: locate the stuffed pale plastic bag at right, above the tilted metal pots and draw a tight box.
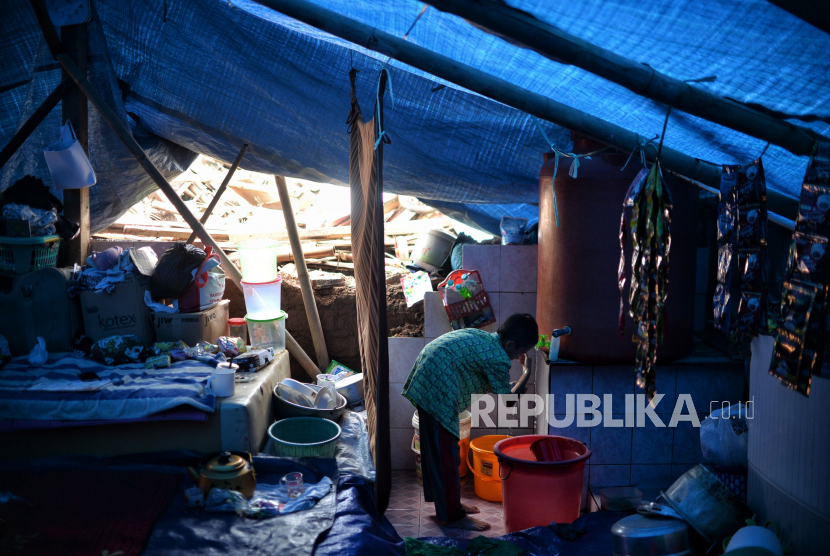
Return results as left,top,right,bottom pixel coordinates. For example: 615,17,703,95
700,403,749,467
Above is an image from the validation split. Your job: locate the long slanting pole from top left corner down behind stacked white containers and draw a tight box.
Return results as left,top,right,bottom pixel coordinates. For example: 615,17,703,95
32,17,317,378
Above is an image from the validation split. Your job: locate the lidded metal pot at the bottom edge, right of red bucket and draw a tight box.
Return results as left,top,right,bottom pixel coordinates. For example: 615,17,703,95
611,514,692,556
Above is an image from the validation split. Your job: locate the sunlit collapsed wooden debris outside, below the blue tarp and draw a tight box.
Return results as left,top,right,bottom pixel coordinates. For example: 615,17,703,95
101,156,464,275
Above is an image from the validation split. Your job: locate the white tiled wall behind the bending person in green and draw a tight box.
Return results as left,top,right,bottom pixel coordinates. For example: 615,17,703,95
389,245,537,469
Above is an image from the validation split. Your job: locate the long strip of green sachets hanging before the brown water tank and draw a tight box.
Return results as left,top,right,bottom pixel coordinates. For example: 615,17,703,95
617,163,671,399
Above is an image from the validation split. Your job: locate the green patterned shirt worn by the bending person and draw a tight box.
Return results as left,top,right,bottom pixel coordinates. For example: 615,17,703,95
403,328,510,438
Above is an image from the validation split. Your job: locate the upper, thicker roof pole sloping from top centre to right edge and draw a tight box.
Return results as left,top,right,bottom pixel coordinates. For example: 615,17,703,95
428,0,830,156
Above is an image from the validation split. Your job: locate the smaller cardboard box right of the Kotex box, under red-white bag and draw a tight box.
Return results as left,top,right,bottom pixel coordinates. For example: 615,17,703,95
151,299,230,347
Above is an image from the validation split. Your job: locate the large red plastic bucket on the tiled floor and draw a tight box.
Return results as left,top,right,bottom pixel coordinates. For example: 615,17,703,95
493,435,591,533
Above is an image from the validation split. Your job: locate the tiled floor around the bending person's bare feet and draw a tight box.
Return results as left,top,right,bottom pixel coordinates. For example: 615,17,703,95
385,471,505,539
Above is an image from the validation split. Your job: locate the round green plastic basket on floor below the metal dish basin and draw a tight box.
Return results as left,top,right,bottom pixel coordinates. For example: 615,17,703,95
268,417,340,458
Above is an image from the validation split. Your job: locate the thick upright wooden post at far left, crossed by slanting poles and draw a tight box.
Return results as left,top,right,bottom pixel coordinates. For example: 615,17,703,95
61,23,90,266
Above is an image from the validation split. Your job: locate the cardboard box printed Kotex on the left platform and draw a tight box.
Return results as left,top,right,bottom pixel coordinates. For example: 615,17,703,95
81,274,155,346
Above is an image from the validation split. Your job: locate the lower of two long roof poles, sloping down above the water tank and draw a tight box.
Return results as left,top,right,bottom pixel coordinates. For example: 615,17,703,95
256,0,798,217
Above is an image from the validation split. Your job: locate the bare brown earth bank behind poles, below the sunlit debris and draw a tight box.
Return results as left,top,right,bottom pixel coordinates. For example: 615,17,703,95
225,276,424,381
